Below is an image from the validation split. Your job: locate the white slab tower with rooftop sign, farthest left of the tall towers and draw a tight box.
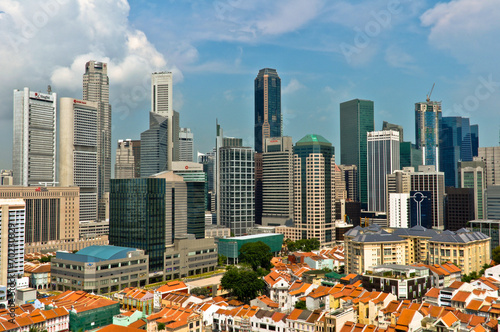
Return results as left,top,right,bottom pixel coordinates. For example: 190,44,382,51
12,88,57,186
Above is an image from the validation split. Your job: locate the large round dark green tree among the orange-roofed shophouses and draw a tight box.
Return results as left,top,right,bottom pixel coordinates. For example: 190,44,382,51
221,267,266,304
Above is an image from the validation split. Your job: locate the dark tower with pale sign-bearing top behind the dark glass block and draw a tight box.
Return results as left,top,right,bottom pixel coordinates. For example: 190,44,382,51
172,161,208,239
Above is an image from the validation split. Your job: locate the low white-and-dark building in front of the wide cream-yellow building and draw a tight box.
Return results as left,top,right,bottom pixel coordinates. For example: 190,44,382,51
362,264,433,301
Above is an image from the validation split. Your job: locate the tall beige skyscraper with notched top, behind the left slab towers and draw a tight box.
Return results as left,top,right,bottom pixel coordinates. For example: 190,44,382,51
83,60,111,220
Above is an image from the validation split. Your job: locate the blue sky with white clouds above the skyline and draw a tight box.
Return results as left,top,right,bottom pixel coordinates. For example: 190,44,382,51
0,0,500,168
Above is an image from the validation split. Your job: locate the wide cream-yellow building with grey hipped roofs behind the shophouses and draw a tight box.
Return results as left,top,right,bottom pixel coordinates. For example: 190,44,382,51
344,225,491,274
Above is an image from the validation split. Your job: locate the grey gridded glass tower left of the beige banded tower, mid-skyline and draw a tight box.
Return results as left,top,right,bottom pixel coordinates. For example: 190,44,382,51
217,146,255,236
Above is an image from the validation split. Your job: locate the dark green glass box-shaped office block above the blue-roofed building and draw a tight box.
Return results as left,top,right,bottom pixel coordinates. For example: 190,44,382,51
109,178,166,272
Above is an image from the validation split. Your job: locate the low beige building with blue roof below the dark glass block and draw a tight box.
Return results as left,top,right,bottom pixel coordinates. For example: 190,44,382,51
51,246,149,294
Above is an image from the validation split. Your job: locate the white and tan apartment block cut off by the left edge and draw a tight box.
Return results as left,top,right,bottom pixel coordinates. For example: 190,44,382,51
0,199,24,297
